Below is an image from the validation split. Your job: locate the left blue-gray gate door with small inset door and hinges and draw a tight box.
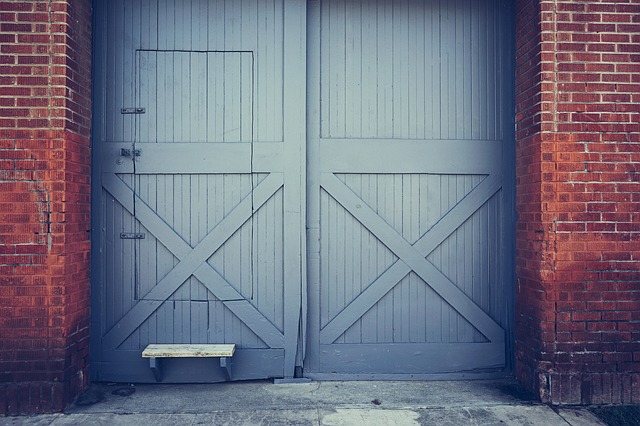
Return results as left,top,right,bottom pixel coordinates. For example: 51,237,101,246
92,0,306,382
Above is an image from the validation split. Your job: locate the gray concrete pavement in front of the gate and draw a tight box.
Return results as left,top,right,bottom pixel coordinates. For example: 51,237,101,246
0,380,603,426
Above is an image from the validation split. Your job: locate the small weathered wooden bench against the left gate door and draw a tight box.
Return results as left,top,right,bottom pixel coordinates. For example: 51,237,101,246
142,343,236,382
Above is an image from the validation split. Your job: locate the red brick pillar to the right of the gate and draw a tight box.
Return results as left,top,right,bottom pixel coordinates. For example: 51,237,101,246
516,0,640,404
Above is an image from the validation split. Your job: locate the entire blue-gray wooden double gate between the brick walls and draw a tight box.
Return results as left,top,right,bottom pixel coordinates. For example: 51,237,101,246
92,0,514,382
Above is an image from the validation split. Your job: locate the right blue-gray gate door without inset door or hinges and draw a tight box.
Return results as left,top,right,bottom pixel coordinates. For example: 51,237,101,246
305,0,513,375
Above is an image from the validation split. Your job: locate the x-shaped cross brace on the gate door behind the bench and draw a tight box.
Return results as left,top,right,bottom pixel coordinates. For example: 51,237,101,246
103,173,284,349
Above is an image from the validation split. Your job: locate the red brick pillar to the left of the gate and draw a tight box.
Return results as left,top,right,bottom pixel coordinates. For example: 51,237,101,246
0,0,91,415
